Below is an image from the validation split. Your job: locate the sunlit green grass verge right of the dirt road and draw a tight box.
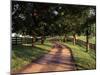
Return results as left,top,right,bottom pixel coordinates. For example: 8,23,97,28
63,42,96,70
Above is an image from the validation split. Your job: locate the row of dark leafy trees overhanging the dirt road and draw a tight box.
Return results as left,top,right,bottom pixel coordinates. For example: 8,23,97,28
12,1,96,51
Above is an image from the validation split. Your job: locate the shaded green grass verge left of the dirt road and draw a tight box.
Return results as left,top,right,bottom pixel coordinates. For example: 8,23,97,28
11,41,52,72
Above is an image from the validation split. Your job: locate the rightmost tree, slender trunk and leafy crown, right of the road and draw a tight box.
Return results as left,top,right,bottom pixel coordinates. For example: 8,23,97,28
79,7,96,52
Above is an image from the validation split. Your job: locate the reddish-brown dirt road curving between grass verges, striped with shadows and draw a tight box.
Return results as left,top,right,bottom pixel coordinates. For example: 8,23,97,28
17,42,75,73
